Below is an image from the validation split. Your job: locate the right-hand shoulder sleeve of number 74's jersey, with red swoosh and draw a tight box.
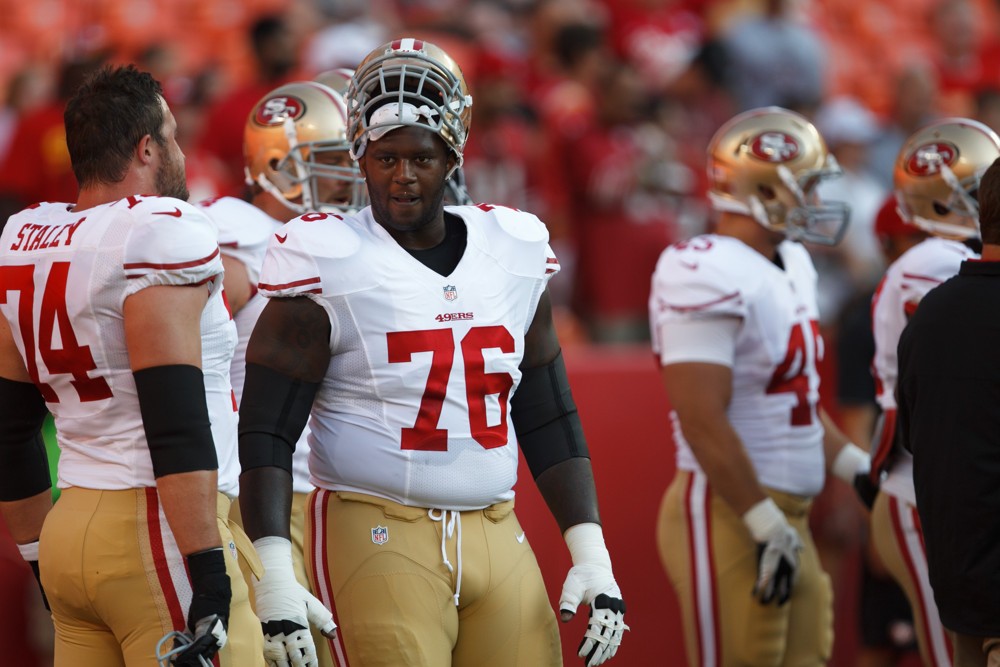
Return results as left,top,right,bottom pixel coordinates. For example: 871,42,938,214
120,197,223,296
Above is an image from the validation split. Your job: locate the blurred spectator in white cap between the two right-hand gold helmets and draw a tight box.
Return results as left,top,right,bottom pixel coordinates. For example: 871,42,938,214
814,97,886,322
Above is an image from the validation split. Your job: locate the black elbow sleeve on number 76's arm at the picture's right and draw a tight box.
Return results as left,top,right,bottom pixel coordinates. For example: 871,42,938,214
510,352,590,479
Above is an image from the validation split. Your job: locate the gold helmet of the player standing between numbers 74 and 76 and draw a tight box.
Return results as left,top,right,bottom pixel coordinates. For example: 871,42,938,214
243,81,367,214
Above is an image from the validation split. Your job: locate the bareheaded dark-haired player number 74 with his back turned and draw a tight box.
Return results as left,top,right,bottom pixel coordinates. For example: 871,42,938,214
0,66,263,667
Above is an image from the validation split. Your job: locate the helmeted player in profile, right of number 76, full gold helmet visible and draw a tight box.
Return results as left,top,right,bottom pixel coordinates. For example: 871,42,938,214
650,107,868,667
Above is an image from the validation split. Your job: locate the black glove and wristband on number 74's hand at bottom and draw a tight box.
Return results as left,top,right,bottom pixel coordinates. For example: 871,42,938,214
170,547,233,667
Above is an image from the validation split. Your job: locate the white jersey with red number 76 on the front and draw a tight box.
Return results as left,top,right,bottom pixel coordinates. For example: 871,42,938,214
254,204,559,510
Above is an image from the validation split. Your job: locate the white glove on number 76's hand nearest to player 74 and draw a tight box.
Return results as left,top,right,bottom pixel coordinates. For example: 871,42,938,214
253,536,337,667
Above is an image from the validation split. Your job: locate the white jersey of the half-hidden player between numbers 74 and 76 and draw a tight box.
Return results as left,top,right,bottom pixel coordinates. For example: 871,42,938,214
198,197,313,493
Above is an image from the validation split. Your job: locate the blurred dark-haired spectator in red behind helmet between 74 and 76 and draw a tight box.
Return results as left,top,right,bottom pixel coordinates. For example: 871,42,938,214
199,15,299,196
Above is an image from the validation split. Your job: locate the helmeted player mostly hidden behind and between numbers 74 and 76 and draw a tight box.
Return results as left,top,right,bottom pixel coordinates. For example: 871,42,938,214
201,75,364,667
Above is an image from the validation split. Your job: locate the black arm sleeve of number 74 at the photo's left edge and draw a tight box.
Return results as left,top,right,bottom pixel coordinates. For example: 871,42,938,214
0,378,52,502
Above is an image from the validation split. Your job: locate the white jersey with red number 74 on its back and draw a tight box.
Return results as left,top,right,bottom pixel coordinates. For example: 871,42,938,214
0,196,239,495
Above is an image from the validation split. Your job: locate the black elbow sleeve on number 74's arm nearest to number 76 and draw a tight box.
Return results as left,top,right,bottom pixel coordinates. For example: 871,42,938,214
132,364,219,478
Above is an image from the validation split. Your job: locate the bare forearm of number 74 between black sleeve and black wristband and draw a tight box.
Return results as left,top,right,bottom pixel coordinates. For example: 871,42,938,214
156,470,222,556
